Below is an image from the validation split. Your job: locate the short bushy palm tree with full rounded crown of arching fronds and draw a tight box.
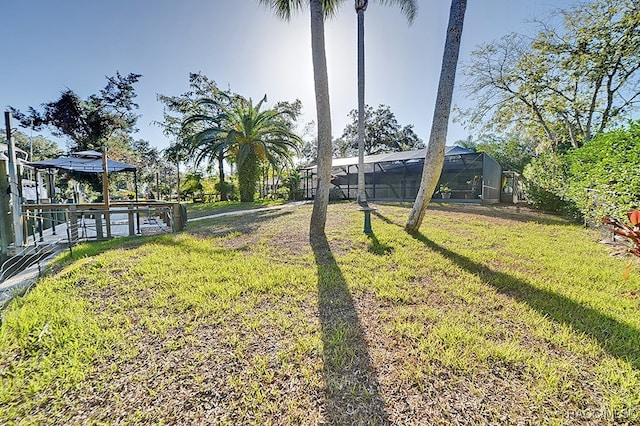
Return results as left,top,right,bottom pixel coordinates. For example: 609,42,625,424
184,95,302,201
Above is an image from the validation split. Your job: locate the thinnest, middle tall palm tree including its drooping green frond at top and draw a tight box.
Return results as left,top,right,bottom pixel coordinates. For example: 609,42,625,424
355,0,418,206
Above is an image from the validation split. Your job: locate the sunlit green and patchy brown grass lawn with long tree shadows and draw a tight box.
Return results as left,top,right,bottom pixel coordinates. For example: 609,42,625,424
0,204,640,425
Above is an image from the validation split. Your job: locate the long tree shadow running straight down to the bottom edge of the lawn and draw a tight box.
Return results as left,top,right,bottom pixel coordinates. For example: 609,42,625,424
310,237,390,425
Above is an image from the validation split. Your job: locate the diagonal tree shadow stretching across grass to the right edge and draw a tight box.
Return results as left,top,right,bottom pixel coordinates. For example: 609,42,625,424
411,233,640,370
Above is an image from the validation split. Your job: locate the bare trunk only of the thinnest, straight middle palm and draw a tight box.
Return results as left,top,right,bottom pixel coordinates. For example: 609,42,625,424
355,0,369,206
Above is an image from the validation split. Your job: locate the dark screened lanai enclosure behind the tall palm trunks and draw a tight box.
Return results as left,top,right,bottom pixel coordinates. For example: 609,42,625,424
301,146,502,204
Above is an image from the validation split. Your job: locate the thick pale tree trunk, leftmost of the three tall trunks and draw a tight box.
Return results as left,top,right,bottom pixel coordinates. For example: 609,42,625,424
309,0,332,237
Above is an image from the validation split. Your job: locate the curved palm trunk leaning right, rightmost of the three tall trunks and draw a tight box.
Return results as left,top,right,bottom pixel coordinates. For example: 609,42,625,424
405,0,467,232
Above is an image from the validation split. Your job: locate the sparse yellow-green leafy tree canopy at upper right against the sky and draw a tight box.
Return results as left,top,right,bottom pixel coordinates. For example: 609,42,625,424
465,0,640,152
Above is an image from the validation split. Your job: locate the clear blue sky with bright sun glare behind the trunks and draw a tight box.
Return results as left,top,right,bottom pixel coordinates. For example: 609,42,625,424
0,0,571,153
